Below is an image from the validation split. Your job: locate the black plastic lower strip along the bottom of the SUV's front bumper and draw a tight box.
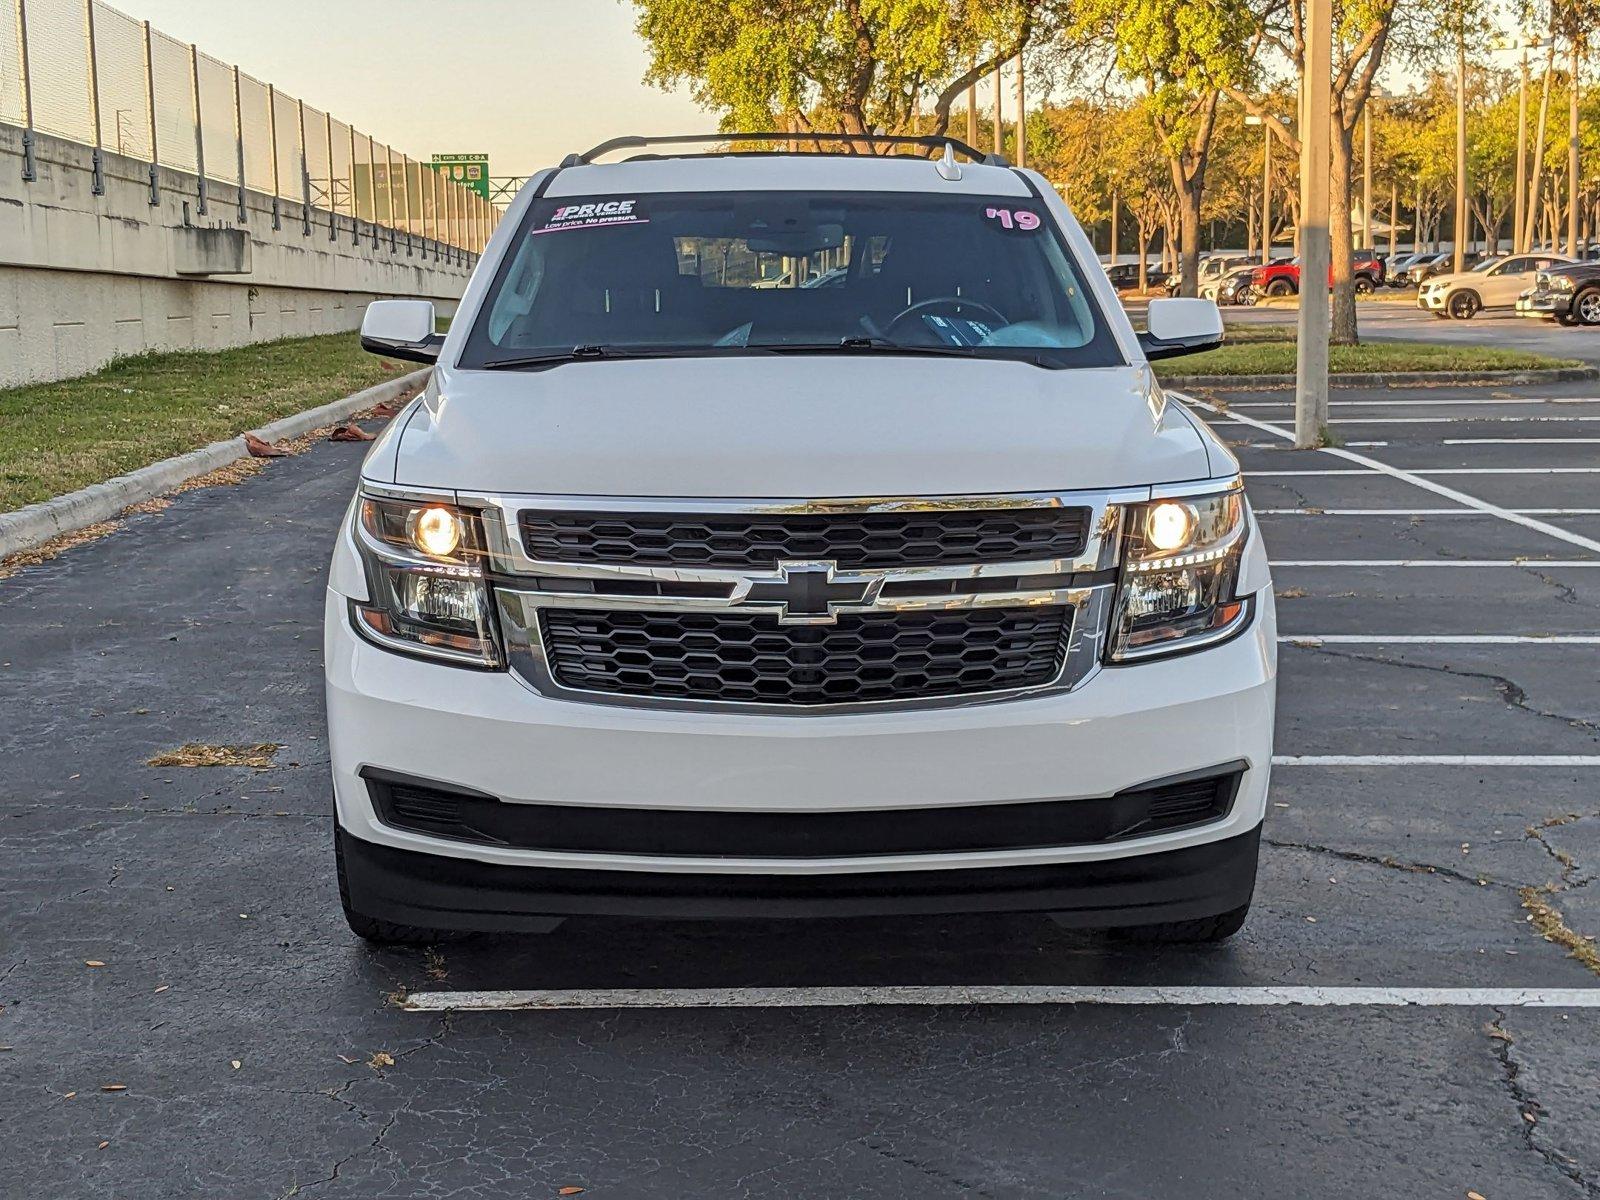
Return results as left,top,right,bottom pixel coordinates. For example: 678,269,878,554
336,826,1261,931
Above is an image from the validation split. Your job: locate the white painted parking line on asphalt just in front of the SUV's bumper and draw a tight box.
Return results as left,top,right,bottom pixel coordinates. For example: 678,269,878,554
402,984,1600,1013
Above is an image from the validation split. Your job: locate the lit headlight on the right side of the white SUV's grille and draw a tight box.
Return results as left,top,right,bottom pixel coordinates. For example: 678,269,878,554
1110,488,1248,662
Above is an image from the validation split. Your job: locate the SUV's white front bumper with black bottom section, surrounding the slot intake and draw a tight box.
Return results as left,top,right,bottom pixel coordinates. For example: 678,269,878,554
326,590,1277,928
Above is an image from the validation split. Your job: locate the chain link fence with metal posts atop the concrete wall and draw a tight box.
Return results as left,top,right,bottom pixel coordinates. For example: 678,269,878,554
0,0,499,253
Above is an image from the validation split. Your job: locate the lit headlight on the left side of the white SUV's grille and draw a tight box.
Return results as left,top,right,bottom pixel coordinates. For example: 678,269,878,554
350,496,502,667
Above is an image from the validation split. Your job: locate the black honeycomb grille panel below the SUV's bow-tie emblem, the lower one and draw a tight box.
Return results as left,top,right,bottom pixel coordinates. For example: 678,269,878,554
539,606,1070,706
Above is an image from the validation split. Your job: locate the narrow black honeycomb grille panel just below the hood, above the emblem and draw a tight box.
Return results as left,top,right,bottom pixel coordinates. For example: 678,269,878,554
522,507,1090,570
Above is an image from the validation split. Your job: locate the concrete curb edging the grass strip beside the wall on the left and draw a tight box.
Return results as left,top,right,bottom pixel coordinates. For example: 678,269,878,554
0,366,432,560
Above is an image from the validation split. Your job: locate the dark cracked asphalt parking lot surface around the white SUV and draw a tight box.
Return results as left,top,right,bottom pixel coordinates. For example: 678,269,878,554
0,377,1600,1200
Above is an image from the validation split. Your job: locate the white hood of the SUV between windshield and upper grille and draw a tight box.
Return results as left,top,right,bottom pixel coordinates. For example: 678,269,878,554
377,355,1210,499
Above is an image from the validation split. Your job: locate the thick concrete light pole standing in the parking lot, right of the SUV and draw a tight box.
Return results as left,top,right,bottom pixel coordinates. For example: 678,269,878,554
1294,0,1333,450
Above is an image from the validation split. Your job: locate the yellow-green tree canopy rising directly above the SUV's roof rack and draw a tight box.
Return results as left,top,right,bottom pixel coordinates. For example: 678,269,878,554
632,0,1067,150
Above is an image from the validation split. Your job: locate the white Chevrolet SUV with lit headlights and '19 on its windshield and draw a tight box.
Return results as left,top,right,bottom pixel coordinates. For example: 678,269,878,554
326,139,1277,941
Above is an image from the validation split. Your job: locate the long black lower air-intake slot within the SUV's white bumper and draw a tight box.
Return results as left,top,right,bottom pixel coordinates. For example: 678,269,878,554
366,763,1243,858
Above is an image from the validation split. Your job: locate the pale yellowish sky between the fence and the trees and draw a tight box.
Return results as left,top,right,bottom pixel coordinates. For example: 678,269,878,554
112,0,717,176
